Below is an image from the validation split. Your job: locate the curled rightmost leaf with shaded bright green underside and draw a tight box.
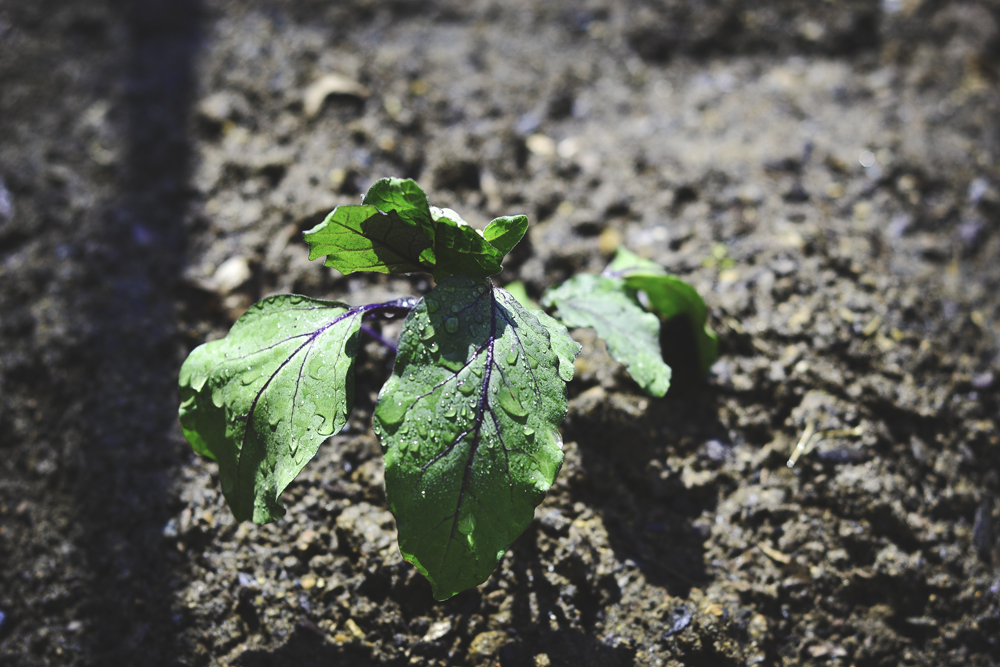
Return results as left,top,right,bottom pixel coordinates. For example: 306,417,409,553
604,247,719,373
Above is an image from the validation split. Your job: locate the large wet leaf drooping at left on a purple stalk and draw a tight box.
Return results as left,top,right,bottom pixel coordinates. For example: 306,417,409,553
180,295,372,523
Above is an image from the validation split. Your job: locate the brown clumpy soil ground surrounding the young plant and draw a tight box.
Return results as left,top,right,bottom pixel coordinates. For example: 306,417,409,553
0,0,1000,667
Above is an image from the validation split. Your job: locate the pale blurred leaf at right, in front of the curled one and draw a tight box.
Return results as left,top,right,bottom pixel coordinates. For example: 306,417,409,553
542,273,670,396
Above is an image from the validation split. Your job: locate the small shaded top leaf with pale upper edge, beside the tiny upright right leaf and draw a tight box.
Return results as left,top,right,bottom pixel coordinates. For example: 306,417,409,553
431,206,503,280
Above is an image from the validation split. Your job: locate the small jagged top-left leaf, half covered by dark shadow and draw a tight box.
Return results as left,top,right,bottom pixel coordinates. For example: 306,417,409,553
305,206,434,275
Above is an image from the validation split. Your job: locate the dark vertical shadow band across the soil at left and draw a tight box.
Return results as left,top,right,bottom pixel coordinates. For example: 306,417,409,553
76,0,200,664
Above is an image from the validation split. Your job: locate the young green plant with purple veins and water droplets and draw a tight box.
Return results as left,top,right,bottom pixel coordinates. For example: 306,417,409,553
180,178,715,600
